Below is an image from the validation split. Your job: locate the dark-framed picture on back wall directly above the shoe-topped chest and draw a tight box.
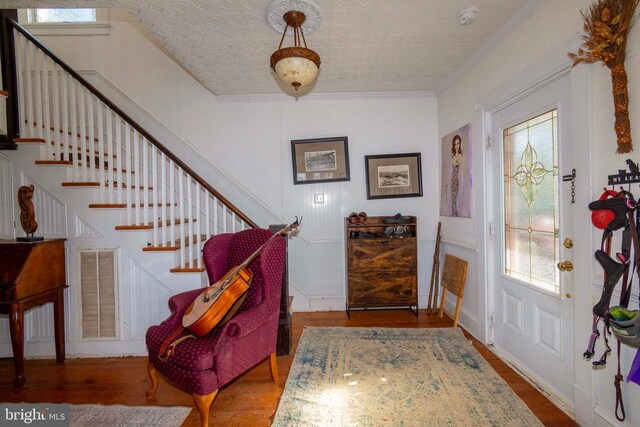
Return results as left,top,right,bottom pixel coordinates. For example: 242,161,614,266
364,153,422,199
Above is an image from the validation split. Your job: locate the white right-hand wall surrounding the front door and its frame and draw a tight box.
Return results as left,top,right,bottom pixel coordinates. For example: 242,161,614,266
438,0,640,425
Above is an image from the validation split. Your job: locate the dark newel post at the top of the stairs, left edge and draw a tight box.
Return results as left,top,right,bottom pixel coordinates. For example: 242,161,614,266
0,9,20,150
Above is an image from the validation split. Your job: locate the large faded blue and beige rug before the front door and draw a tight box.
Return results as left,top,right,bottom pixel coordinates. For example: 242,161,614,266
273,327,542,426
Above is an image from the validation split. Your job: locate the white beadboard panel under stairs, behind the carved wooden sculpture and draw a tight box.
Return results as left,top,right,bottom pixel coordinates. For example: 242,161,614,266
18,173,67,237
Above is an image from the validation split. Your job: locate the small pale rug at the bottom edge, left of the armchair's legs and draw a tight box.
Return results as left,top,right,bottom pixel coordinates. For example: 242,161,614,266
69,405,191,427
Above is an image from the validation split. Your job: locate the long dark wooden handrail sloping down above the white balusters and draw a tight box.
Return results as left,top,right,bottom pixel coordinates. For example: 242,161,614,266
7,17,259,228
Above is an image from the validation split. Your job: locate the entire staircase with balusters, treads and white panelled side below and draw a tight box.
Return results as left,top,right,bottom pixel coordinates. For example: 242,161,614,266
0,19,266,357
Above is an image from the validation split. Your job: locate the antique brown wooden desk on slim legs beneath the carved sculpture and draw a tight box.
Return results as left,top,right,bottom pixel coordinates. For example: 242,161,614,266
0,239,67,388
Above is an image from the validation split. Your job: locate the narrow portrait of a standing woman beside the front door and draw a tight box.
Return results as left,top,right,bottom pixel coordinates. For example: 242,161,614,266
440,125,472,218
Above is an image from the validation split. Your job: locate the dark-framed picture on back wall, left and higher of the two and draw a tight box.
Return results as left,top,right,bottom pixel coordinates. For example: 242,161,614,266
291,136,351,185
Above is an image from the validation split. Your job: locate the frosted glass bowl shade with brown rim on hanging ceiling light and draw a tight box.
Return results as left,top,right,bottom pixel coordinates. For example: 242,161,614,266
271,47,320,90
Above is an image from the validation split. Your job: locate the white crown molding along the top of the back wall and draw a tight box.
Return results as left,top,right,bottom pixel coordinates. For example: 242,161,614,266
216,91,437,103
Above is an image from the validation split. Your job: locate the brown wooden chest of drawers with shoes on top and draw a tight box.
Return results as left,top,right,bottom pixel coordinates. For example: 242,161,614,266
345,216,418,313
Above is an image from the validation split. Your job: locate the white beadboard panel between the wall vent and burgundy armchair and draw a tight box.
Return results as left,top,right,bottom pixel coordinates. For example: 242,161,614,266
127,259,173,340
